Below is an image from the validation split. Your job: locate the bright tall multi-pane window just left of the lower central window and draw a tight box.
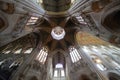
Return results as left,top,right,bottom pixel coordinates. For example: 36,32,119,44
36,47,48,64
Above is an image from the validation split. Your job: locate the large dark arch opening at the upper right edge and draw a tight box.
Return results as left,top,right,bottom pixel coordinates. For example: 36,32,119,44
101,2,120,36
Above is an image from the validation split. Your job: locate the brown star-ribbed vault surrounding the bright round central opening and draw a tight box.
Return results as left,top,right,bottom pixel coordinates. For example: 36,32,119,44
38,17,76,51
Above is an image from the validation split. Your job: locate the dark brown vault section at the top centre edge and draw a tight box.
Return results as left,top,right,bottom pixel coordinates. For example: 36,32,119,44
42,0,71,12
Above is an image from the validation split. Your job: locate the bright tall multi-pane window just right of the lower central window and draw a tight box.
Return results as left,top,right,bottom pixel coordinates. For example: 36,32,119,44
69,47,81,63
